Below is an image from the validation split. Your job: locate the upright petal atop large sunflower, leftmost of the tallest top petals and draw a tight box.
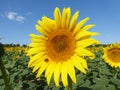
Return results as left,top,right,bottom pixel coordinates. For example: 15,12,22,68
54,7,61,27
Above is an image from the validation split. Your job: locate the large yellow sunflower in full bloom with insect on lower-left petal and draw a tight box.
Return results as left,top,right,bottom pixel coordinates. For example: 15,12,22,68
28,7,98,86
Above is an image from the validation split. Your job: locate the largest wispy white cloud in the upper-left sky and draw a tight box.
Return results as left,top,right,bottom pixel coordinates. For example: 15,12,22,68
6,11,25,22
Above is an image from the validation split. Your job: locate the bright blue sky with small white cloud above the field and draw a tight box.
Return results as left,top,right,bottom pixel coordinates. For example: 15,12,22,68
0,0,120,45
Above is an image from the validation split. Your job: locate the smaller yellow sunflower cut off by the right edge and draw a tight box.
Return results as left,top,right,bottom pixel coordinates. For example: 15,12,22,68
103,43,120,68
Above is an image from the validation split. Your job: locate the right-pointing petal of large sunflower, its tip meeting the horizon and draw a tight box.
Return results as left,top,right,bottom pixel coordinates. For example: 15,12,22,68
76,38,99,48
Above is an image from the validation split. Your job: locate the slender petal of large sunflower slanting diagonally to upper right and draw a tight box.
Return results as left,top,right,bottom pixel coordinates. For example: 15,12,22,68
73,17,89,35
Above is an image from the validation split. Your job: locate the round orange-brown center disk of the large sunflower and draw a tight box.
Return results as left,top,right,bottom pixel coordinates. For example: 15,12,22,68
46,30,75,61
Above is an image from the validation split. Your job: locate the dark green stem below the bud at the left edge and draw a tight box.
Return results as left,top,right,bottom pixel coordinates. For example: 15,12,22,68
0,58,10,90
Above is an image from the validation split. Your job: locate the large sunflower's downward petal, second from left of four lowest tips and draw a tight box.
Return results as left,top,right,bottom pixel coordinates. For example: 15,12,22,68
54,62,61,86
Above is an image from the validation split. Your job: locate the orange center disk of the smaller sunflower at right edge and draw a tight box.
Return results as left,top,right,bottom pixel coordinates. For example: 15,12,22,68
108,48,120,62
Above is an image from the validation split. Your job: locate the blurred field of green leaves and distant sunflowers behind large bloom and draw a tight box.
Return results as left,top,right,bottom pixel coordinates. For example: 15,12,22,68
0,44,120,90
